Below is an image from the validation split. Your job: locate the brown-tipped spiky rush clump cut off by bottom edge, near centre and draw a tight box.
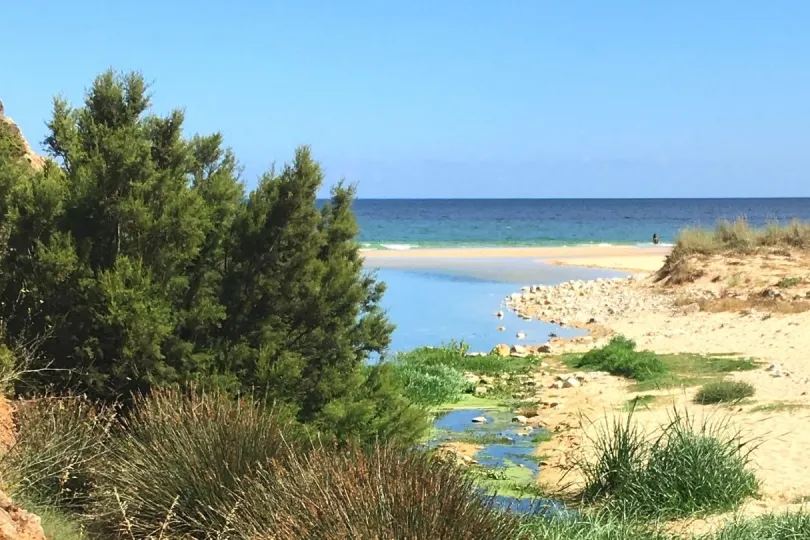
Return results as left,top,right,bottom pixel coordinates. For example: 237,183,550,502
234,447,520,540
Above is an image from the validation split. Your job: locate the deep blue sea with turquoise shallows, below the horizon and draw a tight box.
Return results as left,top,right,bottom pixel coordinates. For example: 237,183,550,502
354,199,810,249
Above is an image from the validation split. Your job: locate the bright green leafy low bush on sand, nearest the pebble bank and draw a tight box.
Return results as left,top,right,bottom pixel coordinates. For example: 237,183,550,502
574,336,667,381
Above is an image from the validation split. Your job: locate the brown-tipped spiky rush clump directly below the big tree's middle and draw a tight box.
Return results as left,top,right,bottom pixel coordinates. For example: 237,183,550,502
90,390,296,538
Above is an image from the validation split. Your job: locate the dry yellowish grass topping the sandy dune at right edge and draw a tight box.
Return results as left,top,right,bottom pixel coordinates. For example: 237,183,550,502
657,217,810,284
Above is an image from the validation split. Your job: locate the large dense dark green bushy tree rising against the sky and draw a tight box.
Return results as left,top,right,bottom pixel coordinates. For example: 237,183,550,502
0,68,422,438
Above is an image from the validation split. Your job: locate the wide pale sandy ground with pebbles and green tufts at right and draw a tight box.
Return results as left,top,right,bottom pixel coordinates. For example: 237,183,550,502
502,255,810,524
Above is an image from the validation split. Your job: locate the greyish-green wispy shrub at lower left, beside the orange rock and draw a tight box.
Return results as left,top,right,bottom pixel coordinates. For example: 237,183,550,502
0,397,114,510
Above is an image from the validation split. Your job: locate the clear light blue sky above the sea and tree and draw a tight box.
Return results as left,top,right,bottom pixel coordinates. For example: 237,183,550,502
0,0,810,198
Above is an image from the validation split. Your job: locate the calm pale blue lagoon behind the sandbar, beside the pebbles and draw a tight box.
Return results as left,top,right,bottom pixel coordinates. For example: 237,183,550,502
378,260,623,351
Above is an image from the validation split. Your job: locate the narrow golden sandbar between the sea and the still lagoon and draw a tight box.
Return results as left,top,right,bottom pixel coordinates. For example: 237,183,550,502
362,246,670,273
